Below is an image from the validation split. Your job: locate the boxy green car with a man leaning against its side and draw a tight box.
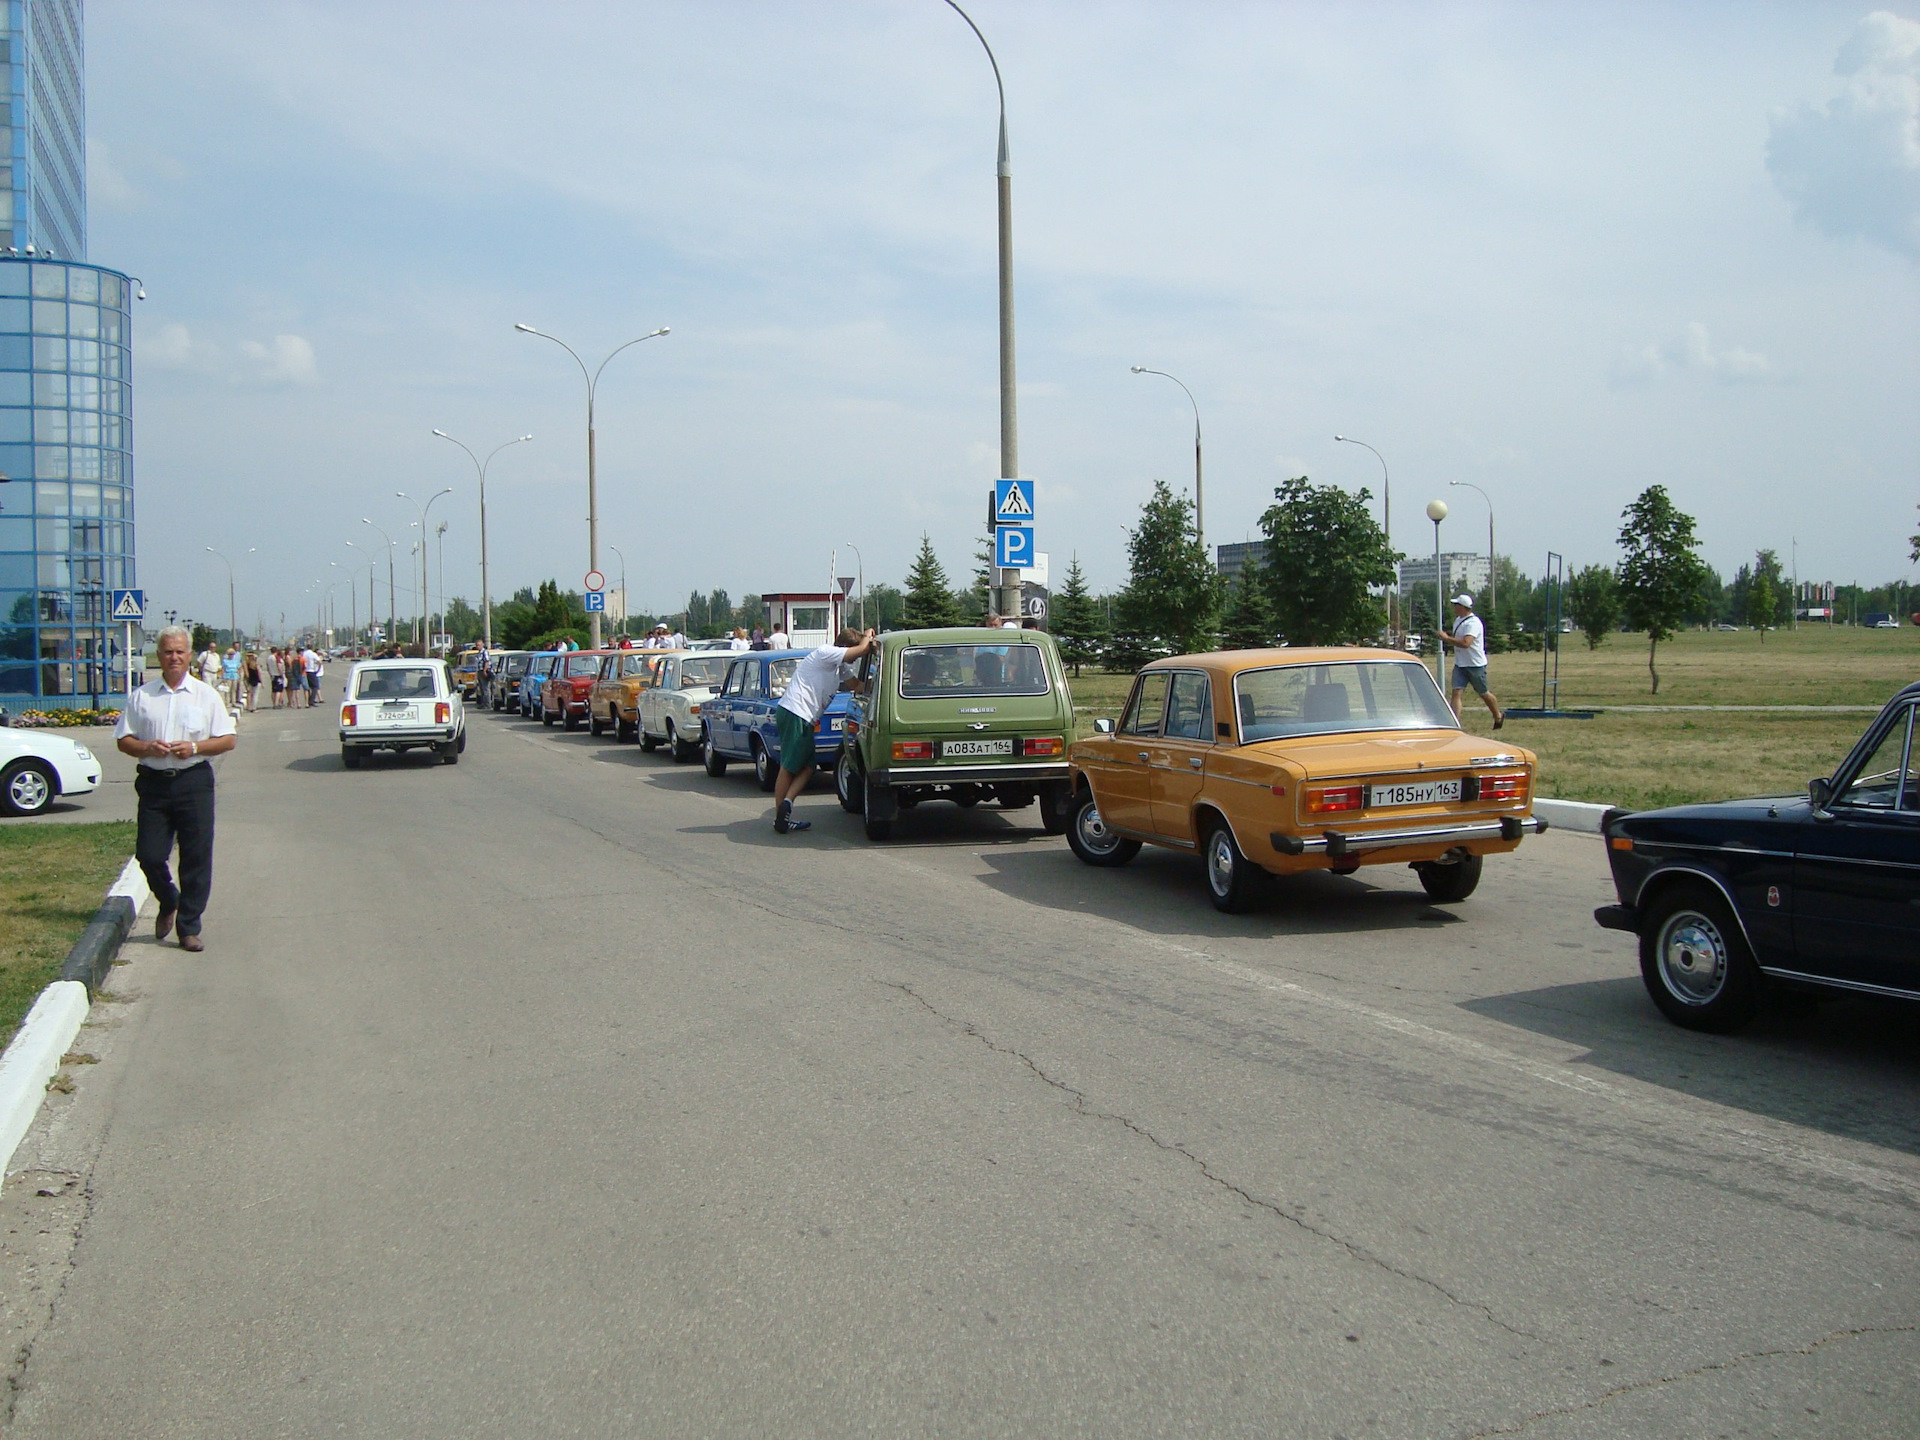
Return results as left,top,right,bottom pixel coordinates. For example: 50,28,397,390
833,628,1073,841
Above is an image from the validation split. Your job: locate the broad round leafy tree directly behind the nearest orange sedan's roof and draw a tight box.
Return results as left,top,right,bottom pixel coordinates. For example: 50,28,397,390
1260,474,1400,645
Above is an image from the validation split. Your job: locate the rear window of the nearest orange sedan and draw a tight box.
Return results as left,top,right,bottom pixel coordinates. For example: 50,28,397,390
1233,660,1459,743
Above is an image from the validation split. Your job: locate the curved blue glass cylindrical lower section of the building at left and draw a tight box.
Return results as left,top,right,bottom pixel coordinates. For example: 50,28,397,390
0,255,138,708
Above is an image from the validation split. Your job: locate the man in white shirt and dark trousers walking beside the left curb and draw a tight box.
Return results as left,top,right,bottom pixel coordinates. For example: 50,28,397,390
113,626,234,950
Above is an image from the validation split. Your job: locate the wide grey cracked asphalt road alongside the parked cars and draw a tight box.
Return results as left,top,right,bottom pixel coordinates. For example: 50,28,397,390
6,695,1920,1440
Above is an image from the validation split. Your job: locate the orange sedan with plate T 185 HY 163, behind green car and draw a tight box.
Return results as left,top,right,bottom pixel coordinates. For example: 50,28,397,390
1068,647,1546,910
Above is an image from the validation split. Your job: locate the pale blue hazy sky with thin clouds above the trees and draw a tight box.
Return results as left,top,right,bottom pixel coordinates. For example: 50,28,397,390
86,0,1920,626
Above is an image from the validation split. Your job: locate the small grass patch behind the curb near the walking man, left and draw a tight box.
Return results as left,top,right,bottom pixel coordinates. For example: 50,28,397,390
0,820,134,1044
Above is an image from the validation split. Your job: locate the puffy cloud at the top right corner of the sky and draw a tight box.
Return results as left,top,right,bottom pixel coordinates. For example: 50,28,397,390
1766,10,1920,261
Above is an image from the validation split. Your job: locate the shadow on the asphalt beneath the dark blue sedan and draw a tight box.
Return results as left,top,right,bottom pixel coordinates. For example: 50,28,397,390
1463,975,1920,1154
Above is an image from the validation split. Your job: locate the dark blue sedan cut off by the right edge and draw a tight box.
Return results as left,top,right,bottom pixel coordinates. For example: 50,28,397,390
1594,684,1920,1031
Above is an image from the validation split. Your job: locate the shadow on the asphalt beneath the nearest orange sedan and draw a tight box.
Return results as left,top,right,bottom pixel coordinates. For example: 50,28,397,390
981,841,1465,939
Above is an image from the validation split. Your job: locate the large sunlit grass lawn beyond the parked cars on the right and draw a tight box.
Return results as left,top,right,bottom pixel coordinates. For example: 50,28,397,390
1069,624,1920,808
